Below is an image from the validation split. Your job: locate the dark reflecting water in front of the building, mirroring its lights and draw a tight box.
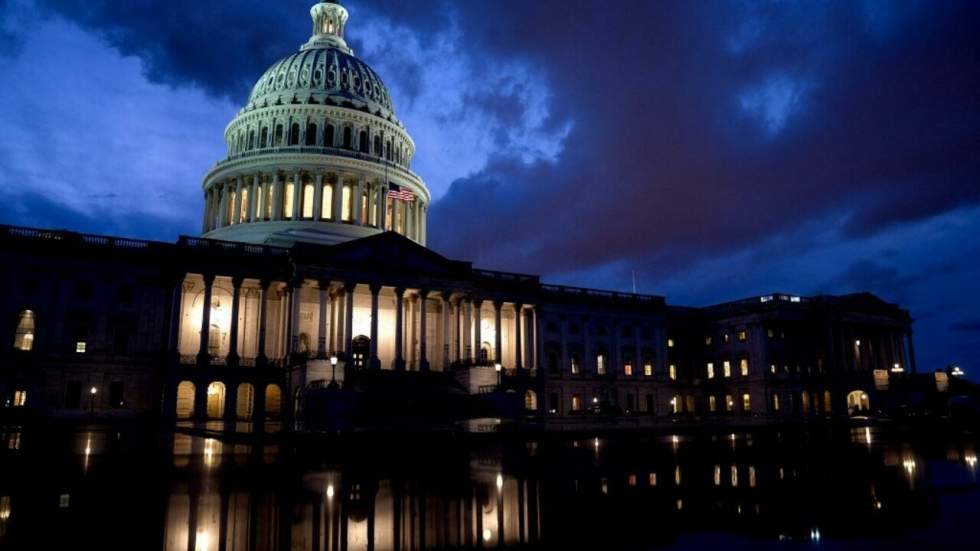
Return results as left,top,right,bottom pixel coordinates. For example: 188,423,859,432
0,427,980,551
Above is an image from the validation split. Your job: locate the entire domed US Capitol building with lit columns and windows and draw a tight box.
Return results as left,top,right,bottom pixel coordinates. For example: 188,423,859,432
0,2,916,430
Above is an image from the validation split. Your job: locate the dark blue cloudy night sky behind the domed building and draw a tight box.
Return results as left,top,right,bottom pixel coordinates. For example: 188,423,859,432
0,0,980,379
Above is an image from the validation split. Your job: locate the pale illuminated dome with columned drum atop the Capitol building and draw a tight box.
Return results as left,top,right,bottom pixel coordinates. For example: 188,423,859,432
204,2,430,245
